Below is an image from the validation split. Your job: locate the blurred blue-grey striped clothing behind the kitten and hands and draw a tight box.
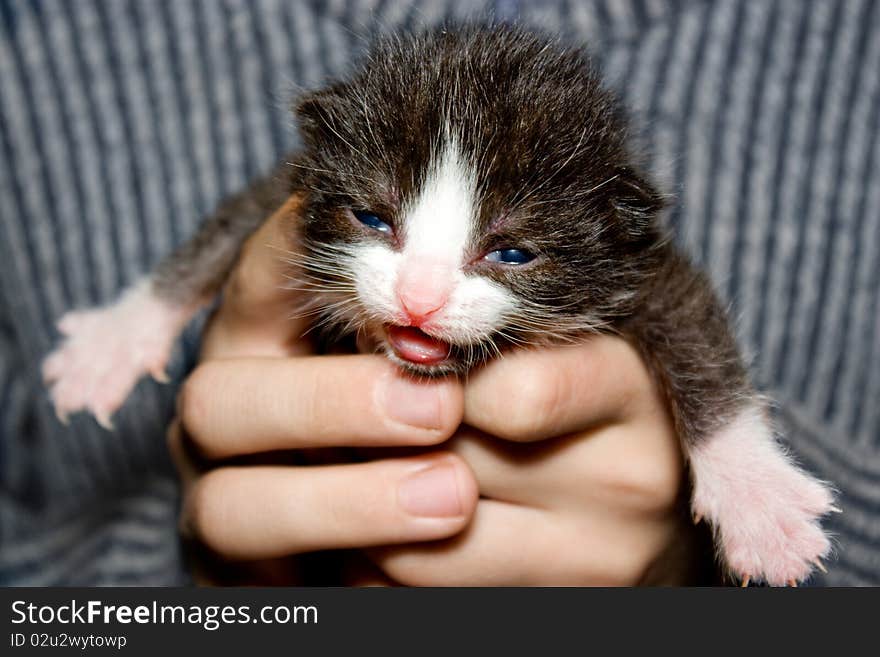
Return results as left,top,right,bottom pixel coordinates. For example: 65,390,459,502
0,0,880,585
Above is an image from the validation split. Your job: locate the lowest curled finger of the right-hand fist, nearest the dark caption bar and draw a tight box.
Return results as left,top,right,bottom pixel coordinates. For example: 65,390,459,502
368,499,669,586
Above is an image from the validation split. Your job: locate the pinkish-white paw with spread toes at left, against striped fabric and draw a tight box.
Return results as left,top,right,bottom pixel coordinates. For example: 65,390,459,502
42,282,192,429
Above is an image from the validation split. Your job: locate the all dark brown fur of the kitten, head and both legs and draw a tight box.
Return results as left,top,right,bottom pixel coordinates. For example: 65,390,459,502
154,28,752,452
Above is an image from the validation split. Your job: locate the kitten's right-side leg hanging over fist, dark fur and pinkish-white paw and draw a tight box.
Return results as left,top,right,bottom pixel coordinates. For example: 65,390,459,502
623,247,834,585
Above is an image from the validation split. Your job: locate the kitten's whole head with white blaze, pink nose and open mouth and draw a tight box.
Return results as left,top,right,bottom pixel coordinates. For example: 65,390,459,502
294,27,659,375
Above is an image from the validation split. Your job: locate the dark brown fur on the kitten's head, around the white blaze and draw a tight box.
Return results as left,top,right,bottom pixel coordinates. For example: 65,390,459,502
296,28,662,332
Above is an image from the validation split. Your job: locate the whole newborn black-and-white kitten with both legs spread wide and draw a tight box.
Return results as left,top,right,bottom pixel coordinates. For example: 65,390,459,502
44,27,834,585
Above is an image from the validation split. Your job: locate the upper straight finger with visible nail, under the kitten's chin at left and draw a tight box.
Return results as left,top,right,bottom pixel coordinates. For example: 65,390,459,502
180,355,462,458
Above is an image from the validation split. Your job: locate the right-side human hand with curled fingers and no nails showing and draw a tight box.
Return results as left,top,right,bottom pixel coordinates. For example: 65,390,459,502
365,336,712,586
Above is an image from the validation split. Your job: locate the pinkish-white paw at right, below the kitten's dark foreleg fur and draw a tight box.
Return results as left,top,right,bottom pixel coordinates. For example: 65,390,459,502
691,407,836,586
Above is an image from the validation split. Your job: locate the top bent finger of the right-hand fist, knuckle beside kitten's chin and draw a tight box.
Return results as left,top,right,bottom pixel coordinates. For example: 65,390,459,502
464,336,658,441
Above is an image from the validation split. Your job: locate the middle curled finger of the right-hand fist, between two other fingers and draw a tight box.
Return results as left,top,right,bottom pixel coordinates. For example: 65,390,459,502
447,419,684,517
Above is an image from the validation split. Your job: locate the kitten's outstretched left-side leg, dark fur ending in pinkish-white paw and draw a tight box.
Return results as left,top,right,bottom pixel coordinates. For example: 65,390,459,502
42,158,291,429
